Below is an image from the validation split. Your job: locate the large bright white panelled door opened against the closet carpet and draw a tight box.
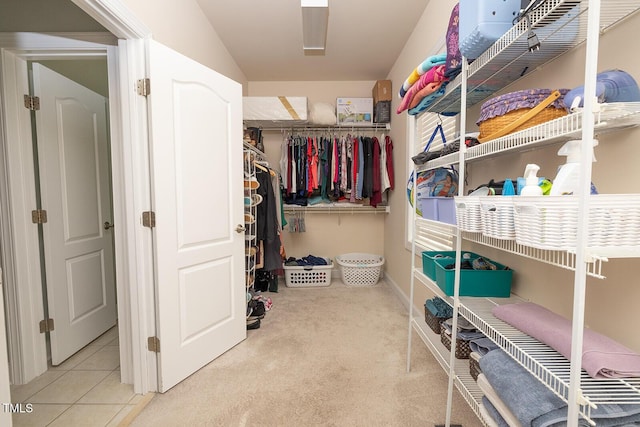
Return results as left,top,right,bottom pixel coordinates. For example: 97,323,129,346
148,41,246,392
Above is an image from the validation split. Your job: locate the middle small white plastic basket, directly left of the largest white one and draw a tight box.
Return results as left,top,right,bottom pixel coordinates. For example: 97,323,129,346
479,196,516,240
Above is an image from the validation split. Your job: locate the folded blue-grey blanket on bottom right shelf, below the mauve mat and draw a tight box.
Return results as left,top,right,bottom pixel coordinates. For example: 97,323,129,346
480,350,640,427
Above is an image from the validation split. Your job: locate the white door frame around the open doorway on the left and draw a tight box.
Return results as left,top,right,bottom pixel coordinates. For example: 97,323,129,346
0,0,157,393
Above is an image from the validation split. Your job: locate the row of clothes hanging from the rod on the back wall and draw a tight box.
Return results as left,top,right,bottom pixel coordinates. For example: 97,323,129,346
280,135,394,207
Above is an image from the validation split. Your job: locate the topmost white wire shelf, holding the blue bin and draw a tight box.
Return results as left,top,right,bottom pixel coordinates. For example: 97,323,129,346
427,0,640,113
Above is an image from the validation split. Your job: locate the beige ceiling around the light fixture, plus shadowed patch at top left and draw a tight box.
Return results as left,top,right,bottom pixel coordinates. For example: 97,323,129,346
0,0,429,81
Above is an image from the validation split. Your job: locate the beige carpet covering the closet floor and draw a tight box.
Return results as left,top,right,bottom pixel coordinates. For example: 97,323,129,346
131,279,482,427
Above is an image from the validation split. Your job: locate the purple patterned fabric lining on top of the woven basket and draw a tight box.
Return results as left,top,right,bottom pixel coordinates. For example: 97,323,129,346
476,89,568,125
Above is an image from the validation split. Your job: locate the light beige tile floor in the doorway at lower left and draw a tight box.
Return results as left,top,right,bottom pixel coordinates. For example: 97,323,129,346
11,327,143,427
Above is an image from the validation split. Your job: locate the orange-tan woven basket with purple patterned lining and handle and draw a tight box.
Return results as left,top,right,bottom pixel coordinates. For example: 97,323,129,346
477,89,567,142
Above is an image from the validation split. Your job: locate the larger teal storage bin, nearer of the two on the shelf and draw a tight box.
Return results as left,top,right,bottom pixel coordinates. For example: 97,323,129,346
433,258,513,298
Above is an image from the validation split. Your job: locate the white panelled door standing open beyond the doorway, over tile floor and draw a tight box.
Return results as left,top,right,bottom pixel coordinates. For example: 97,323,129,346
33,64,116,365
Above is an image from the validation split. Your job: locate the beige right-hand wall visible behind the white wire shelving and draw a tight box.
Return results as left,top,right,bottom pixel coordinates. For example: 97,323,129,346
385,2,640,351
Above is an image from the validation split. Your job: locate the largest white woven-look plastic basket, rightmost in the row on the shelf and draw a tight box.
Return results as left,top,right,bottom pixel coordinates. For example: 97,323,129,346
513,194,640,250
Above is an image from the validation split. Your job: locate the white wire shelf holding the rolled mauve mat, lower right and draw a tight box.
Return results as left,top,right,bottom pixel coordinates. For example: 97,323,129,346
460,297,640,424
